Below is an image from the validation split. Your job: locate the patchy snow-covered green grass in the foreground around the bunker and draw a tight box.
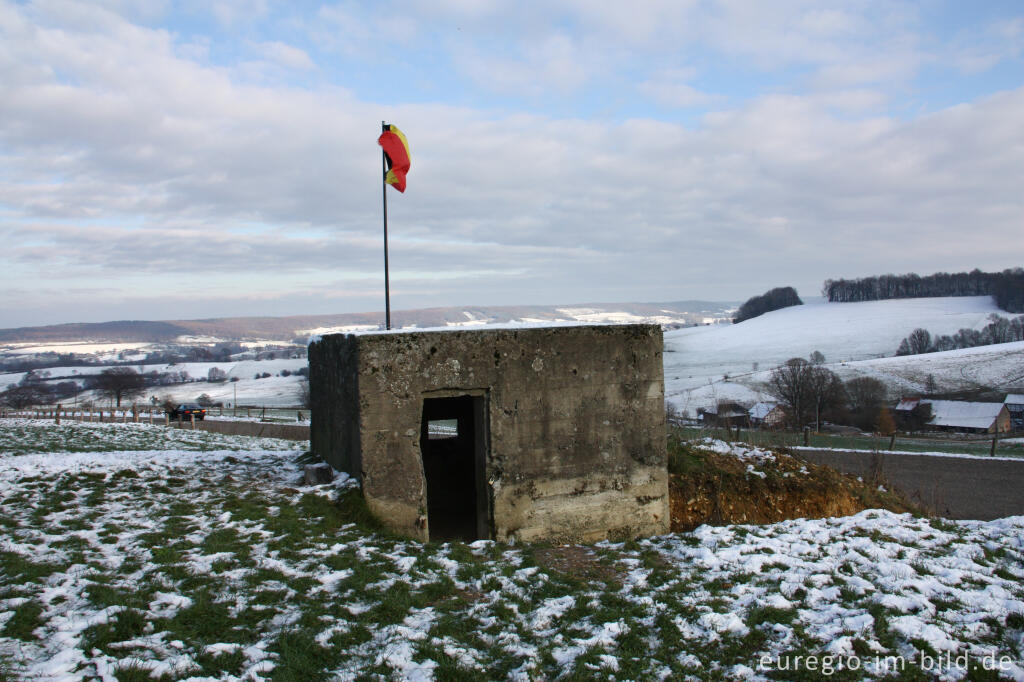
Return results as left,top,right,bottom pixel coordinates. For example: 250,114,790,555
0,420,1024,680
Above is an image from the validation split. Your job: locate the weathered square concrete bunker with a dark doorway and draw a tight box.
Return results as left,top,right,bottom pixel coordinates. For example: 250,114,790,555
309,325,669,541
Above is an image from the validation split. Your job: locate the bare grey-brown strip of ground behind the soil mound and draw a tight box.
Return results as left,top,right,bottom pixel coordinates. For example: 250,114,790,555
793,449,1024,521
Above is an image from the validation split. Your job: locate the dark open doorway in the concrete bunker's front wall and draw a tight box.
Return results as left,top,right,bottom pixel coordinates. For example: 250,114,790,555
420,395,490,542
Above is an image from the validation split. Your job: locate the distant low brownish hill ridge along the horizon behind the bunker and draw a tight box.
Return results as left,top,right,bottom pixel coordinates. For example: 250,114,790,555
0,301,735,344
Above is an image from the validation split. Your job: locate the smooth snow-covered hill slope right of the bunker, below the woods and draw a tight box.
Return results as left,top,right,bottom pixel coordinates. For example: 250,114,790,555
665,296,1024,413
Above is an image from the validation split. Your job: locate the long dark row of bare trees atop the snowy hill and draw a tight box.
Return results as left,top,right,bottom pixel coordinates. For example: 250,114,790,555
821,267,1024,312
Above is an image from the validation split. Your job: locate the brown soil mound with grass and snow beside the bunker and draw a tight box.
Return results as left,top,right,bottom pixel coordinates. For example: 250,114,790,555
669,441,920,531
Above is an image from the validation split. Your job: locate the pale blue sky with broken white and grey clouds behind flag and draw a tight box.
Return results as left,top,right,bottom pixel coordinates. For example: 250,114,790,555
0,0,1024,327
